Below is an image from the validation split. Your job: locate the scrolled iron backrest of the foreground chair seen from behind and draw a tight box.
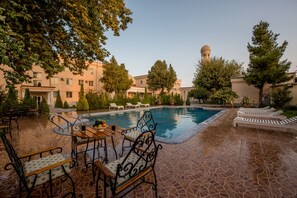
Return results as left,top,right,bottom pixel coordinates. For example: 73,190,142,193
113,131,162,188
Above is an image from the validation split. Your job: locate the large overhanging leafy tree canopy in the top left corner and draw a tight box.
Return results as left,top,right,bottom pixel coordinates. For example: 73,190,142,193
0,0,132,84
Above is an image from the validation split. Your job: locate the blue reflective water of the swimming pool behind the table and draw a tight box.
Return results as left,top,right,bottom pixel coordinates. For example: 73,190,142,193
90,107,223,143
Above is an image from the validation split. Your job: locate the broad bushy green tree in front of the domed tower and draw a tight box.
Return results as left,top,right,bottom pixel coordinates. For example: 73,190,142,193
193,57,242,90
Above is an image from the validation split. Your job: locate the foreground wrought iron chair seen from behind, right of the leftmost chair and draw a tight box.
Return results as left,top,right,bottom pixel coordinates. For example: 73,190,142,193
95,131,162,197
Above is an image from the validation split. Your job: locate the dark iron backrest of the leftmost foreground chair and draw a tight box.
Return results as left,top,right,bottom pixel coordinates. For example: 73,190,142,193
0,132,27,188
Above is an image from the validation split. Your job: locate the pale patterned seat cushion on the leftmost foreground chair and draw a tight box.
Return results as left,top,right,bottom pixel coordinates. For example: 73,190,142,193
24,154,70,187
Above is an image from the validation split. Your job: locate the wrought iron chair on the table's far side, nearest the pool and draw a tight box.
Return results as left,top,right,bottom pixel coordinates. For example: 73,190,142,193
121,111,157,155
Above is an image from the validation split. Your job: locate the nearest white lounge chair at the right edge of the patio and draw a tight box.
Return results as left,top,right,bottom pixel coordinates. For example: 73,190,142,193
233,116,297,132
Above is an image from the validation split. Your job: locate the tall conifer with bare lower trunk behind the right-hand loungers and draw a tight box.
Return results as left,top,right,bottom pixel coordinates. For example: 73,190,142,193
244,21,291,104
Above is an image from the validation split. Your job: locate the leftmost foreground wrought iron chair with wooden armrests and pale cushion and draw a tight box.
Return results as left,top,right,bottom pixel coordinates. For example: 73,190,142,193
0,132,75,197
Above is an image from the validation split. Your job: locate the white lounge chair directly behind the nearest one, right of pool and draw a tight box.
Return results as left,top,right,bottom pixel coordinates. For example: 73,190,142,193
237,110,287,120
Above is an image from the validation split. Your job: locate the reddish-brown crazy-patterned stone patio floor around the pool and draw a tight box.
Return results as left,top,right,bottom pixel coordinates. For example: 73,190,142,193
0,109,297,198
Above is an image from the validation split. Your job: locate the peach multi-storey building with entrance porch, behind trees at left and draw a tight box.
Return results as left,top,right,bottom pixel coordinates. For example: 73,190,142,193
0,62,103,106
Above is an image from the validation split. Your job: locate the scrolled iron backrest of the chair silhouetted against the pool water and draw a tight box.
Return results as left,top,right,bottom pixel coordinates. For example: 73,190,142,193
136,111,157,132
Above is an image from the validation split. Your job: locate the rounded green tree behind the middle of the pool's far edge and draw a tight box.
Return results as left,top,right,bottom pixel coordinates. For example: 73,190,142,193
146,60,177,94
